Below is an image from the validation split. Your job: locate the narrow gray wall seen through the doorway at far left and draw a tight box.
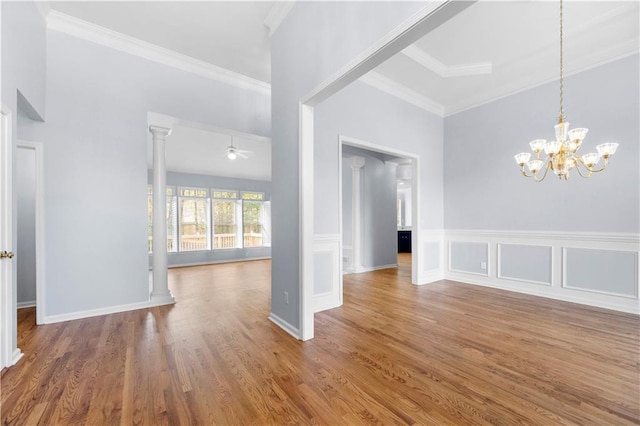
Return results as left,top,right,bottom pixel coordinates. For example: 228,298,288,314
14,148,36,305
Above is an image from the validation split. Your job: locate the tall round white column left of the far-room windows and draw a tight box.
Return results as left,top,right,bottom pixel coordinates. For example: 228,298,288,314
149,126,175,305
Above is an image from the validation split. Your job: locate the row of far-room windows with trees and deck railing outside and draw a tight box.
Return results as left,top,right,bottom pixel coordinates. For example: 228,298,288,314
147,185,271,252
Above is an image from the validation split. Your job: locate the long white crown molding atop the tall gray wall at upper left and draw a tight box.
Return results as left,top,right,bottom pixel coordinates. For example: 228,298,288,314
47,10,271,95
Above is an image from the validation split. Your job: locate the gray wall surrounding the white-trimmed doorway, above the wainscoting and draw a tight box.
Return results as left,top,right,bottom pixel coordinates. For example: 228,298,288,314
314,82,444,234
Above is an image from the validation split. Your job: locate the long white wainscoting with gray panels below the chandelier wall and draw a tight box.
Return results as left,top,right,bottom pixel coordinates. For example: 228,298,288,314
444,230,640,314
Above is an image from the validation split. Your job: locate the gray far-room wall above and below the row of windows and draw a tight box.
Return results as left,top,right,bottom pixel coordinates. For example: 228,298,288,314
148,170,271,267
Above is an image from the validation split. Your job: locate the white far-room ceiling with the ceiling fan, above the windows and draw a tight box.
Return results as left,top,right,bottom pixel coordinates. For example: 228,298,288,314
147,125,271,180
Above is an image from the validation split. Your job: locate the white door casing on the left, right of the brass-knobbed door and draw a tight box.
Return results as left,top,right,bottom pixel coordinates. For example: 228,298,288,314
16,140,46,324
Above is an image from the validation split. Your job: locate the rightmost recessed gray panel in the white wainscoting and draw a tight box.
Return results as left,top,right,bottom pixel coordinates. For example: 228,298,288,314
562,247,638,299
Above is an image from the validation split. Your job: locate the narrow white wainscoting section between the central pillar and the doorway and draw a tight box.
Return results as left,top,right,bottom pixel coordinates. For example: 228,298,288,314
313,234,342,312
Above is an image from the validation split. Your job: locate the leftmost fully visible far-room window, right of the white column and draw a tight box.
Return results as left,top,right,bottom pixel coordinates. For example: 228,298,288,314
179,188,211,251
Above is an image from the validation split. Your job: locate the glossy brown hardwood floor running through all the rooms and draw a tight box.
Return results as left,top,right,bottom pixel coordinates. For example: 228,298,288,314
1,257,640,425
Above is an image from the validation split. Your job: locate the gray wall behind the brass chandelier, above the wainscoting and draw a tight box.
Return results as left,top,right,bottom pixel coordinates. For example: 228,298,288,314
444,55,640,233
